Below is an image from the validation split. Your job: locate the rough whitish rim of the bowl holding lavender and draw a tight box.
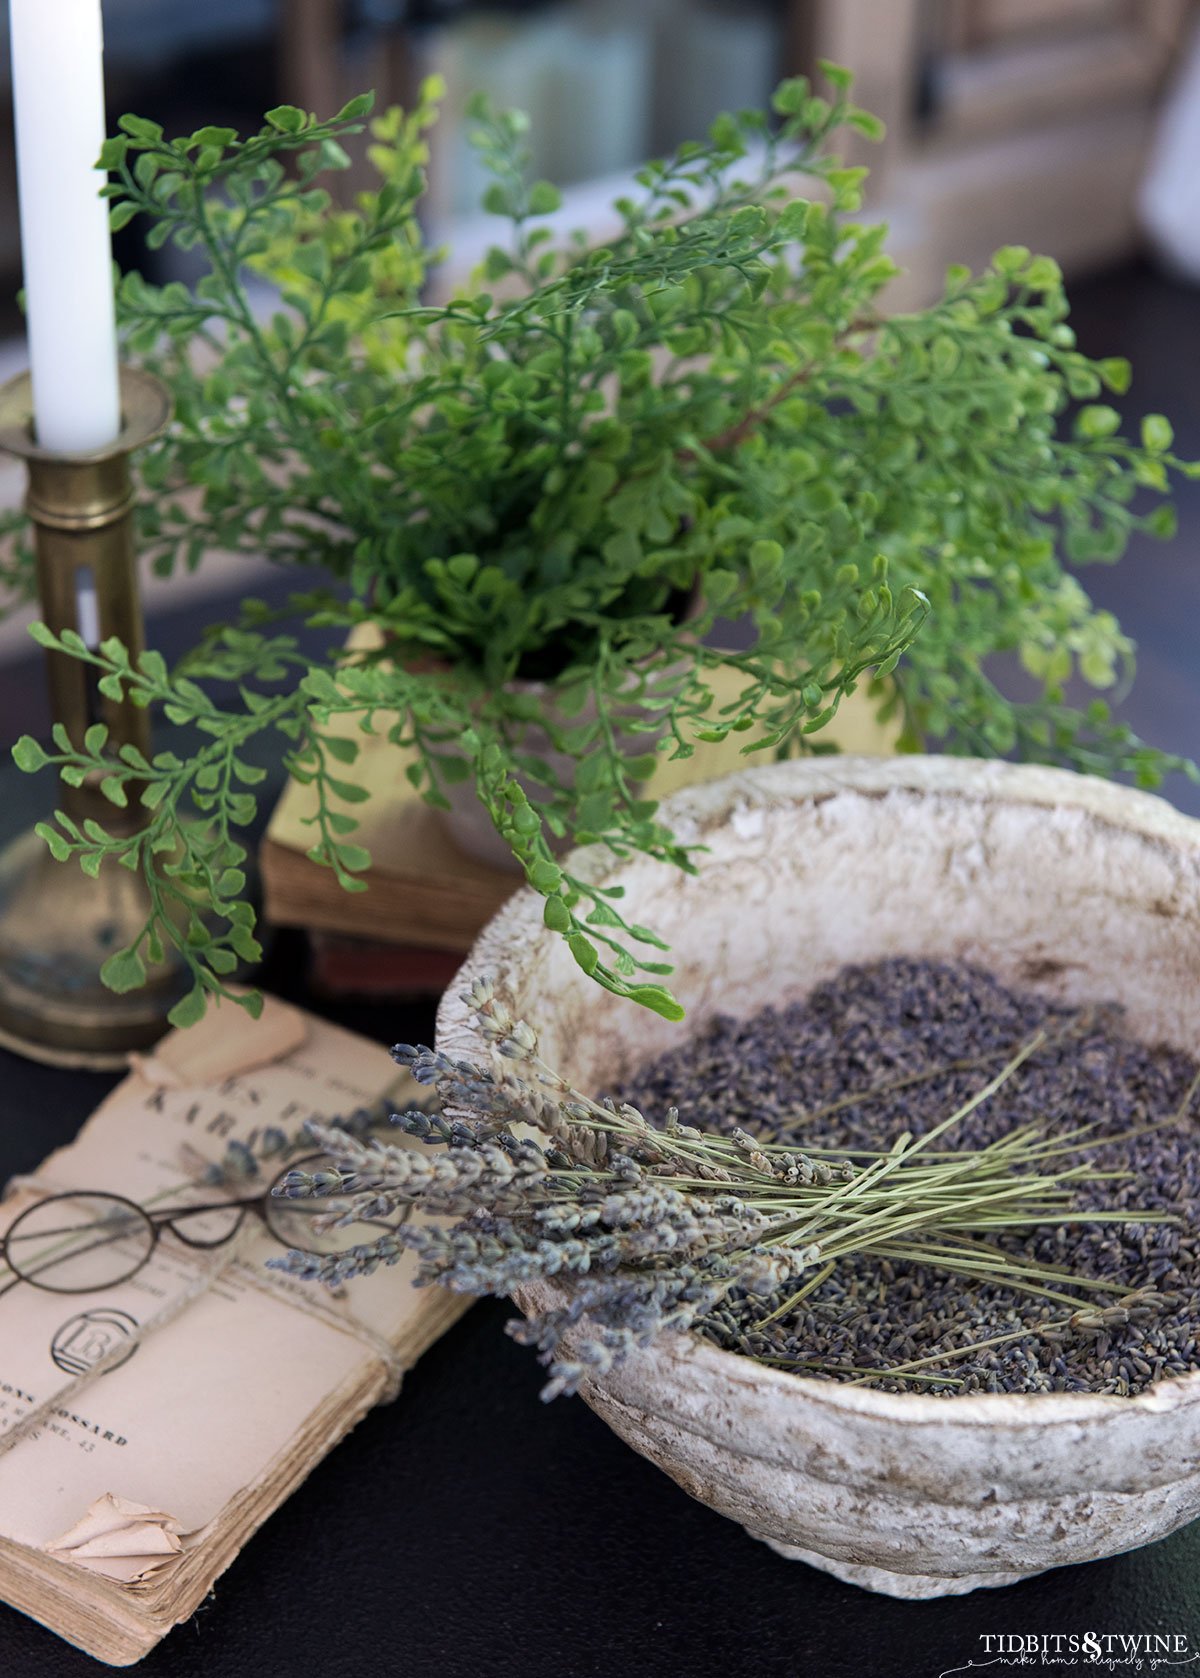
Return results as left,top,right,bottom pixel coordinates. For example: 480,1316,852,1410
436,757,1200,1436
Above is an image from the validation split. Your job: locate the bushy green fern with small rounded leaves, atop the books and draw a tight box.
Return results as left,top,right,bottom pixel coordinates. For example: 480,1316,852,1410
4,65,1192,1019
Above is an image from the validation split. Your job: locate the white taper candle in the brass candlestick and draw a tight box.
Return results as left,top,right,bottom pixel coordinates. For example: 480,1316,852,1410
10,0,121,455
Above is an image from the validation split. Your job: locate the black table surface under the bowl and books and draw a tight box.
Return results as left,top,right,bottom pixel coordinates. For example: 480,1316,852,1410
0,251,1200,1678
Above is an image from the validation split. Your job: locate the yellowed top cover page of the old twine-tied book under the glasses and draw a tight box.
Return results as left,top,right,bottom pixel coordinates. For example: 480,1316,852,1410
0,1002,445,1586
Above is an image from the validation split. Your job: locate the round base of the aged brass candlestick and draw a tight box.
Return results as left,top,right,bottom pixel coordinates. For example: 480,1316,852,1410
0,832,188,1071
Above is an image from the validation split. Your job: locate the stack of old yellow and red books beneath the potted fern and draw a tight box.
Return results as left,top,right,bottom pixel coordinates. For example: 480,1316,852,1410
258,670,896,966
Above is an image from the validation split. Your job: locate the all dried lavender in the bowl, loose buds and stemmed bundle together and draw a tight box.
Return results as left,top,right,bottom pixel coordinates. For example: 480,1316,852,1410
266,961,1195,1398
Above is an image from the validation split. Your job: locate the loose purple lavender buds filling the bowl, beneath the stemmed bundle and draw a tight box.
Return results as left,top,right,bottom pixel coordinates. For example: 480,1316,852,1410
628,960,1200,1396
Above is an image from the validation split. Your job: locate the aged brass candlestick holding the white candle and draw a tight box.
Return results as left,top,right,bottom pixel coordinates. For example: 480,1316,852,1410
0,367,185,1067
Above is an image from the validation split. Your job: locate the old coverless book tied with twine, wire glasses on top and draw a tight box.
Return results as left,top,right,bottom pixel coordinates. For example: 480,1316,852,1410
0,998,467,1666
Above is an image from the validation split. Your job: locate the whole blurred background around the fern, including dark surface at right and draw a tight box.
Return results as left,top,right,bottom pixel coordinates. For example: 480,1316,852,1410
0,0,1200,812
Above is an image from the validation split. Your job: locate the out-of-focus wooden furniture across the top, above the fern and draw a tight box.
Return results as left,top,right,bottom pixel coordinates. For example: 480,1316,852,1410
0,0,1195,305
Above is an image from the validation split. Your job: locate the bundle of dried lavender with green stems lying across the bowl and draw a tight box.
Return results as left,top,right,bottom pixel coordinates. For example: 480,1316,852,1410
265,982,1161,1399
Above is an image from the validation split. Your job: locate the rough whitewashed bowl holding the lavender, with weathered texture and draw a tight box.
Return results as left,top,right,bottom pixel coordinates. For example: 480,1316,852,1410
438,758,1200,1597
